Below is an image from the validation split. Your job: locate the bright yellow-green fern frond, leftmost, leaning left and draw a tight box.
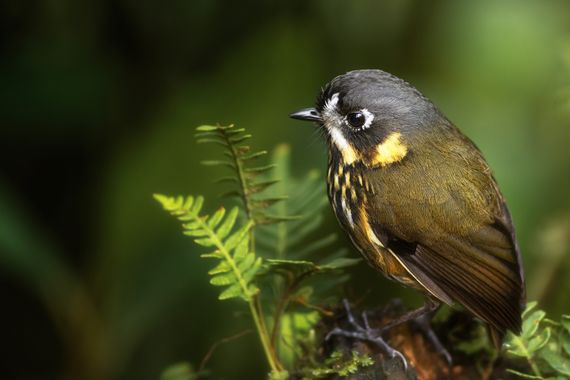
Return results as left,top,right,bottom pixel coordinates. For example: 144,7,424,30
154,194,262,302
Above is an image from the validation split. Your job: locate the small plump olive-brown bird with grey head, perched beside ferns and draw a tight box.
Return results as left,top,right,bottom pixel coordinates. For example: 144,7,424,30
290,70,526,360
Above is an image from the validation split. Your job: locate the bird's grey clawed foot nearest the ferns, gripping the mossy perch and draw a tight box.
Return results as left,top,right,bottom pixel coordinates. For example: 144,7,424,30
325,300,408,371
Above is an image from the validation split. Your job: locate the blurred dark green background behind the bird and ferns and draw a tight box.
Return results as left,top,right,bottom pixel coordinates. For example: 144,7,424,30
0,0,570,380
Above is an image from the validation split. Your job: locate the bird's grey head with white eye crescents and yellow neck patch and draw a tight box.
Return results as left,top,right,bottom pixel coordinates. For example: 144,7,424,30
290,70,443,166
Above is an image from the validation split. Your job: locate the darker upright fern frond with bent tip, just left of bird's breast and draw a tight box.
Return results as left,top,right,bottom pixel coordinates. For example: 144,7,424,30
196,125,284,224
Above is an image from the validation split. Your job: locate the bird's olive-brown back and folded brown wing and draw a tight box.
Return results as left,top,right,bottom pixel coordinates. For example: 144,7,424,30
369,136,524,333
